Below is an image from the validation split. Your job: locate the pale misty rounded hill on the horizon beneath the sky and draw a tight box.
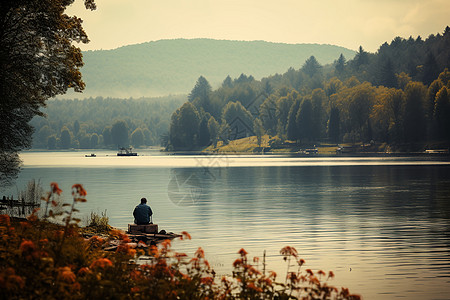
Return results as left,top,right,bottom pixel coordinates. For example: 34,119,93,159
65,39,356,98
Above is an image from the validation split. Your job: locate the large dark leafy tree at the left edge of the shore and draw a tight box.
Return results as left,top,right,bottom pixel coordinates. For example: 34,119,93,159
0,0,95,184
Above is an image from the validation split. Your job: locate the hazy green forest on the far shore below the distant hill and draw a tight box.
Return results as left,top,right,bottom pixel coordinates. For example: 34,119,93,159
31,96,186,149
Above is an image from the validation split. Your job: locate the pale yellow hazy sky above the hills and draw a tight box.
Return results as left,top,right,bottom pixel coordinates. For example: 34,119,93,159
68,0,450,52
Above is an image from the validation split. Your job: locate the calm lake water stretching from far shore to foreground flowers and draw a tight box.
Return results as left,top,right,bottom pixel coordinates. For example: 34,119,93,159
3,151,450,299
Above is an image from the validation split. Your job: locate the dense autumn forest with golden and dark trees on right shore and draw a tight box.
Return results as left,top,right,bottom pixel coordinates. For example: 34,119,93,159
167,27,450,151
